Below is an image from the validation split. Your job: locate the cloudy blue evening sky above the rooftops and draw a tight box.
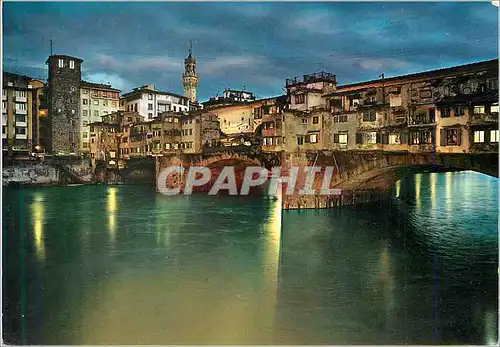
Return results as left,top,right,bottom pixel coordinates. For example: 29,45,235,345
3,2,498,101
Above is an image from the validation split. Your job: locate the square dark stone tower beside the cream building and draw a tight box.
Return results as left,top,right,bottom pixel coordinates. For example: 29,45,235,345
46,55,83,154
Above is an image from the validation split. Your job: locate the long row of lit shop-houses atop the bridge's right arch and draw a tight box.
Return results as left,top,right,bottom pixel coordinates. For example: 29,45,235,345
325,60,498,153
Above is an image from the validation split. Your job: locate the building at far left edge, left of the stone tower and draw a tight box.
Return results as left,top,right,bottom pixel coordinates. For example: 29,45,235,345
2,72,46,154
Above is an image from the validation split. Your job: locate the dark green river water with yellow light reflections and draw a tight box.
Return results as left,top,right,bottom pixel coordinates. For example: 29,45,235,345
2,172,498,344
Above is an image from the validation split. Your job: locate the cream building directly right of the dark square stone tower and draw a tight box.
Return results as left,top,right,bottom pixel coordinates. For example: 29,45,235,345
79,81,120,152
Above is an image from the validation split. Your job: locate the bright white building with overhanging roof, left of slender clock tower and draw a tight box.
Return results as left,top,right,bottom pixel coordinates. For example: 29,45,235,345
120,84,190,121
